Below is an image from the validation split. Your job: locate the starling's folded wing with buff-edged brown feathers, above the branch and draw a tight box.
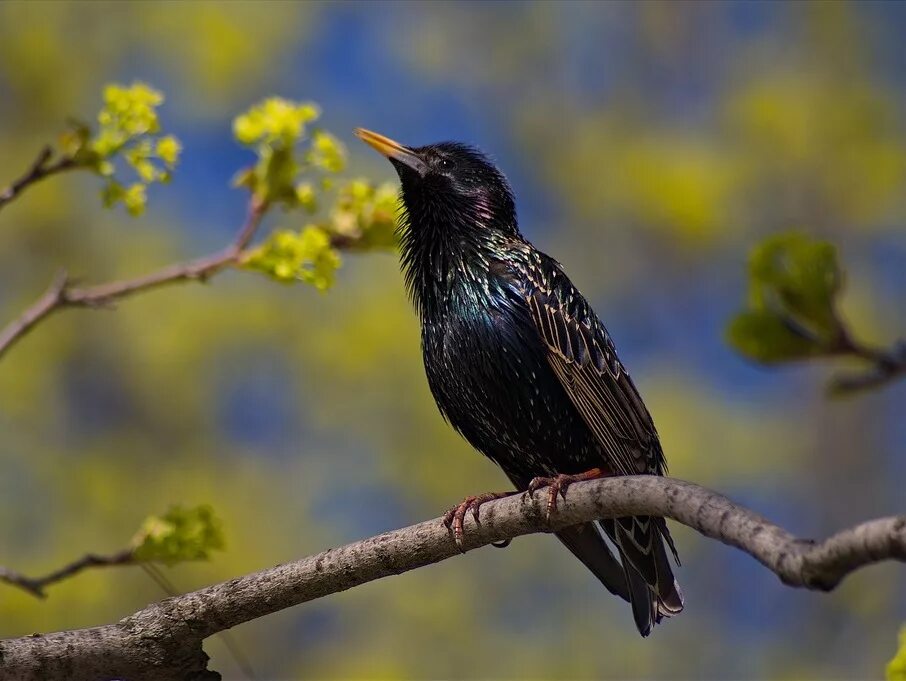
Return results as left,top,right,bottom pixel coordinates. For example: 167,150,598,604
508,254,666,475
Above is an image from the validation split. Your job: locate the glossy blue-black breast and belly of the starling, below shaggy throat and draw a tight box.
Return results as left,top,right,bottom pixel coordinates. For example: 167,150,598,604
422,288,588,478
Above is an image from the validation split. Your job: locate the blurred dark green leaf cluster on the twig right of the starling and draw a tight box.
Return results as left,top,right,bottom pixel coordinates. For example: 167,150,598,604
727,232,843,362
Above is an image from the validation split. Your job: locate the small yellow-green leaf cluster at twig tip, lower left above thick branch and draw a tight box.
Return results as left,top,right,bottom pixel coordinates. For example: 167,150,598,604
132,505,224,565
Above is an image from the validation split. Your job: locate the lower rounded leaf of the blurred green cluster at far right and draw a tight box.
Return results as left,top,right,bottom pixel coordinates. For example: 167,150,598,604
727,310,823,364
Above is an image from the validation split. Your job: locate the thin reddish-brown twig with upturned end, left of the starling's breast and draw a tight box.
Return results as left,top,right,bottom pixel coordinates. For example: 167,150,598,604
0,197,268,357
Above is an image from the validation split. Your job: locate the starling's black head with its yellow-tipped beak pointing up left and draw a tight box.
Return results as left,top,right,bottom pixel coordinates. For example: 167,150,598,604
355,128,519,241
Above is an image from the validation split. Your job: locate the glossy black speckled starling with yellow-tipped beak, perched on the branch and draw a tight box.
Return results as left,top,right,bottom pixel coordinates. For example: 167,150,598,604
355,128,684,636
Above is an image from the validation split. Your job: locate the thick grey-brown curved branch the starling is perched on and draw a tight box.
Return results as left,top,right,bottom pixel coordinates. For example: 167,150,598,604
0,476,906,681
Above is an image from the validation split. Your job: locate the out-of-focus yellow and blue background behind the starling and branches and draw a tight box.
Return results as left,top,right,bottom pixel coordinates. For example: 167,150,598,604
0,1,906,679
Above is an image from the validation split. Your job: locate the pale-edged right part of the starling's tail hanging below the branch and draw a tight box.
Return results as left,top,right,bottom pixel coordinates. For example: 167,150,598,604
601,516,683,636
